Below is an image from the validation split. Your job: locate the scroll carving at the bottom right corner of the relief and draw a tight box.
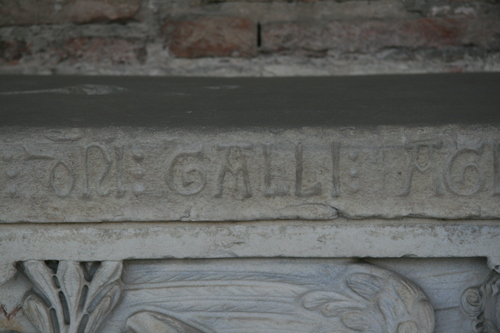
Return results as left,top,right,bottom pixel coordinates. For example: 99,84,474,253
462,272,500,333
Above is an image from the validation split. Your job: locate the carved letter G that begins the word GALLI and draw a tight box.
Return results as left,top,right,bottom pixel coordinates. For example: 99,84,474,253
166,150,207,196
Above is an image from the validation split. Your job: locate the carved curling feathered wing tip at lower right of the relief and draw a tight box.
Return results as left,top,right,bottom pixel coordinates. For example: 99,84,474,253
302,273,434,333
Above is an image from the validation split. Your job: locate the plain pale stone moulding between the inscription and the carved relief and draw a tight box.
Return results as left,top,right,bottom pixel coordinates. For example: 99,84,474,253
0,219,500,268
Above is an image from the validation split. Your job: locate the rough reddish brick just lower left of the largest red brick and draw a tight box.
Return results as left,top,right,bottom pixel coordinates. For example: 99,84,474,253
55,37,147,65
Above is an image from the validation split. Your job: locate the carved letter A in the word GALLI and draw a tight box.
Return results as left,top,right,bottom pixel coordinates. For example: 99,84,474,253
215,144,252,198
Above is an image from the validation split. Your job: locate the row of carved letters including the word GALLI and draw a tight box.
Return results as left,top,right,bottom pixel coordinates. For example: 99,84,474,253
2,141,500,199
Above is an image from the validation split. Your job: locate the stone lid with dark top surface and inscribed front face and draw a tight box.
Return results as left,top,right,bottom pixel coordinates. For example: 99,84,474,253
0,74,500,222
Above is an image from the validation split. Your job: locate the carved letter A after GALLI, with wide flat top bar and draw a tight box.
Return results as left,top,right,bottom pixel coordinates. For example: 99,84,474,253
400,141,442,196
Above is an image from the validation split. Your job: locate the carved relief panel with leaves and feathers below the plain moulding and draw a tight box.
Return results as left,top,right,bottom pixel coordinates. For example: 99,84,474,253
0,258,499,333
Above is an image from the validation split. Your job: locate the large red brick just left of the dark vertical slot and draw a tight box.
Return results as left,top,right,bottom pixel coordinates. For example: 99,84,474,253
162,17,257,58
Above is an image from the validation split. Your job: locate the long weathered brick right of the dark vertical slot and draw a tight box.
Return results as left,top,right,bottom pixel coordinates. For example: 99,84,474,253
262,18,500,53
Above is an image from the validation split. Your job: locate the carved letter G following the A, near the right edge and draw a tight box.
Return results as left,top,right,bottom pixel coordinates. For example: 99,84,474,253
444,146,484,195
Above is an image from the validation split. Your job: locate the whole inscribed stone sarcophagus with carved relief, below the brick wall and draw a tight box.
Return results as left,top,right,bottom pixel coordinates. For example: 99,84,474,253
0,74,500,333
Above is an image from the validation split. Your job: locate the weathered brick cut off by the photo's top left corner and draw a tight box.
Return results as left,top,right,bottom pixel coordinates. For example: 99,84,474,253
0,0,142,26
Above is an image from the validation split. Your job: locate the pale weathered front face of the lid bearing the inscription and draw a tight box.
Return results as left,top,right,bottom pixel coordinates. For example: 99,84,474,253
0,132,500,220
